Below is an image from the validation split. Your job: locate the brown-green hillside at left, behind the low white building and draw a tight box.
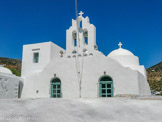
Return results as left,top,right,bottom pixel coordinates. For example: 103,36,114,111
0,57,21,76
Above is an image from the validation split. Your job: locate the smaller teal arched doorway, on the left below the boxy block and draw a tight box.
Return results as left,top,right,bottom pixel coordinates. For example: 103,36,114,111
51,78,62,98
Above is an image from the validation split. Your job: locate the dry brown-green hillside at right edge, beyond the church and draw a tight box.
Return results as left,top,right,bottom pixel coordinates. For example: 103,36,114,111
147,62,162,94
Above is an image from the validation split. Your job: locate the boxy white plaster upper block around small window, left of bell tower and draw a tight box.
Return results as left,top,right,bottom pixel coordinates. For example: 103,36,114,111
21,42,64,77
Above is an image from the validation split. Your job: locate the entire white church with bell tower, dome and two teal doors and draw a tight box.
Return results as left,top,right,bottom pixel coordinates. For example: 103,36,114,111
21,12,151,98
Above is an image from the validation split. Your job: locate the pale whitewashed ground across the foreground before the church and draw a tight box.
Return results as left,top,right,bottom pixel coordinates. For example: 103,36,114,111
0,98,162,122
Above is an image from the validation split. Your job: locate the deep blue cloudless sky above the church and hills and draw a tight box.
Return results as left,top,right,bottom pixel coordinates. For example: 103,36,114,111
0,0,162,67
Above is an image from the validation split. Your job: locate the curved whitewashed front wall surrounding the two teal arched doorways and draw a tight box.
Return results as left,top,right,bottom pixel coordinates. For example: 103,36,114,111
23,52,150,98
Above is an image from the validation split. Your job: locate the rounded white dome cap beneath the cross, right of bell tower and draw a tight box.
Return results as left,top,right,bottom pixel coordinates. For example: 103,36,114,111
108,48,134,57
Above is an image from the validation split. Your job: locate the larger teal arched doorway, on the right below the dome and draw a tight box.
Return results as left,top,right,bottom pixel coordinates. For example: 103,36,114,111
99,76,113,97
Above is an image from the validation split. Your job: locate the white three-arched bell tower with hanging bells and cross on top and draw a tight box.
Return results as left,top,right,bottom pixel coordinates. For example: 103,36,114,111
66,11,96,54
